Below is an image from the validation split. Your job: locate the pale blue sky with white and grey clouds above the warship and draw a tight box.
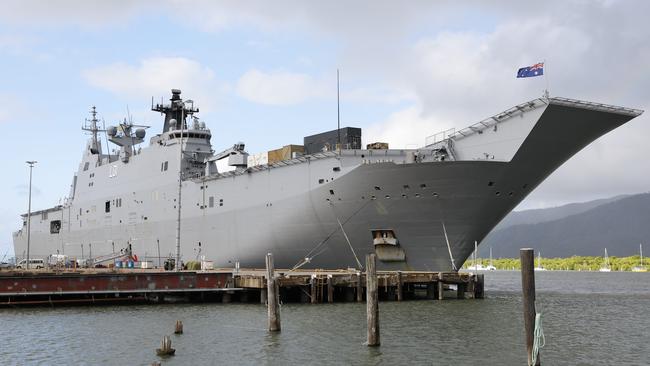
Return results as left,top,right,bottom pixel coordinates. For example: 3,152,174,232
0,0,650,260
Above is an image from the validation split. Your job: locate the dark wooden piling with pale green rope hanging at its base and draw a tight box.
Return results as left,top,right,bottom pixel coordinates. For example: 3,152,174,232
519,248,540,366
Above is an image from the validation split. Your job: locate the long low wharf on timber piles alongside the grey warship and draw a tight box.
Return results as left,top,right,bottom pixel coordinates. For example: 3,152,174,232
0,268,484,307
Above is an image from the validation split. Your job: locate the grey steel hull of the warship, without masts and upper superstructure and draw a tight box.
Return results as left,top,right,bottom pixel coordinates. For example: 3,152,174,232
14,96,638,271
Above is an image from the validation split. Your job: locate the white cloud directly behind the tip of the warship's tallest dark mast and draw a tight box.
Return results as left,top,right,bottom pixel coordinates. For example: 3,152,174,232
82,57,225,109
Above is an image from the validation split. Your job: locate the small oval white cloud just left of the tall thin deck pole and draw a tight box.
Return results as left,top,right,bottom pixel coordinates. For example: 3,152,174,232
237,69,324,105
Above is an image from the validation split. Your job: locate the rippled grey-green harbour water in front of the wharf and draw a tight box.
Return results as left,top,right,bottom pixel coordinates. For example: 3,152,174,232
0,271,650,365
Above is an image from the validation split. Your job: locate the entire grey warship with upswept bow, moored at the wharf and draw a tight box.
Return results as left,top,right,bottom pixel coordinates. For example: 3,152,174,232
13,90,642,271
